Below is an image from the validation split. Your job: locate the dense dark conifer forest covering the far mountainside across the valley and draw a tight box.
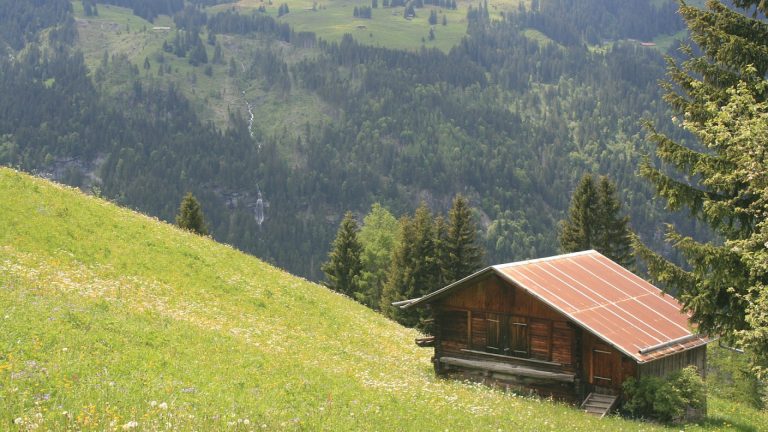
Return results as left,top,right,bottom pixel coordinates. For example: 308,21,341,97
0,0,695,279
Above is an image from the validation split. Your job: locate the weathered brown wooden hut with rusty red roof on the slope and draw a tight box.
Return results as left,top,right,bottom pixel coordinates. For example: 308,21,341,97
398,250,710,414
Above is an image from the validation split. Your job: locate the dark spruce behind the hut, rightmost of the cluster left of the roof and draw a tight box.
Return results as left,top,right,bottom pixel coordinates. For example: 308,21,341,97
441,195,483,283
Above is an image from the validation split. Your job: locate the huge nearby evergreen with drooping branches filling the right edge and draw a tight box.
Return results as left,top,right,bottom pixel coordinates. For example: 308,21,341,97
636,0,768,376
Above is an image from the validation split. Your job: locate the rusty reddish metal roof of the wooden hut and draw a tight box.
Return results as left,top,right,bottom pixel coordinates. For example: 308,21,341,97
404,250,711,363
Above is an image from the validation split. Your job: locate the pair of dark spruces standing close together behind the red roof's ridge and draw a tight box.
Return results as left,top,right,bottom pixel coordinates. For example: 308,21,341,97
560,174,634,268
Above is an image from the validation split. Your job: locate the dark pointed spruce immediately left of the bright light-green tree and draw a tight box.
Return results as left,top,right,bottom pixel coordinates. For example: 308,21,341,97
321,212,363,297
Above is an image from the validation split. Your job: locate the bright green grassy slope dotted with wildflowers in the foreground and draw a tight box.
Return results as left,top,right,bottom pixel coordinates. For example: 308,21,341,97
0,168,768,431
